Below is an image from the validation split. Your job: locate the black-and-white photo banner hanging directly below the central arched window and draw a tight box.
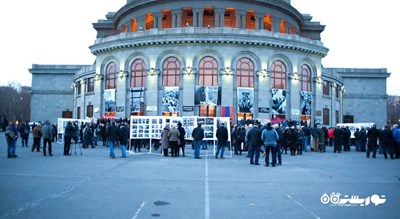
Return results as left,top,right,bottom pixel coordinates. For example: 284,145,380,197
194,86,219,106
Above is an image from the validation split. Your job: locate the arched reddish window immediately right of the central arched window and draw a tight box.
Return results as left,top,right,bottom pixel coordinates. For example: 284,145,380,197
236,58,254,87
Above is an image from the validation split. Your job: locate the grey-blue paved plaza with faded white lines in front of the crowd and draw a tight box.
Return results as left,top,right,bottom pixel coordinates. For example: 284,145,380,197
0,133,400,219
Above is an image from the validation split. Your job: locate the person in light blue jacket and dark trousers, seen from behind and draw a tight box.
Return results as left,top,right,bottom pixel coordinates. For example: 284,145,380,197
261,123,279,167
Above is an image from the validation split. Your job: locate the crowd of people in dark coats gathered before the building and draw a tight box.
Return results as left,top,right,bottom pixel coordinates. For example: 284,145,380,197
5,119,400,164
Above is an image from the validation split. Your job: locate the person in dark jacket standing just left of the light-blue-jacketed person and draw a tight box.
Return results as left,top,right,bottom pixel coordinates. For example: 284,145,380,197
247,124,263,165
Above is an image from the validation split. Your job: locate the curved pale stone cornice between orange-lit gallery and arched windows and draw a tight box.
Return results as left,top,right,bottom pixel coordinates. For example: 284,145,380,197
90,27,328,58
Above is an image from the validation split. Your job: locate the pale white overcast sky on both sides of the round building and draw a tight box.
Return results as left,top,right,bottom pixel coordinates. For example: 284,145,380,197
0,0,400,96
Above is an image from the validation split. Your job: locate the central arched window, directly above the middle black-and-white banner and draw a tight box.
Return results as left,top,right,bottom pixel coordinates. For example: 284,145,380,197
199,56,218,86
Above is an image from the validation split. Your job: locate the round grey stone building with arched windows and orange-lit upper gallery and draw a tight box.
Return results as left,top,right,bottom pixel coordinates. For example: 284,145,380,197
30,0,389,126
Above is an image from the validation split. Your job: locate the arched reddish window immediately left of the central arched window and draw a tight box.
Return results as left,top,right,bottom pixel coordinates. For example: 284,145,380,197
162,57,181,87
